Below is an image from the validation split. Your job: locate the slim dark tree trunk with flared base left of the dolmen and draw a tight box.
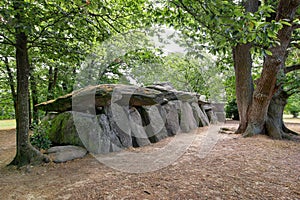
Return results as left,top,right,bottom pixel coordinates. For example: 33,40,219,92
11,1,46,166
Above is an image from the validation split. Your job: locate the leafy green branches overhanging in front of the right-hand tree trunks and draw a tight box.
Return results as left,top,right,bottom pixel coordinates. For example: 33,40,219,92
154,0,287,55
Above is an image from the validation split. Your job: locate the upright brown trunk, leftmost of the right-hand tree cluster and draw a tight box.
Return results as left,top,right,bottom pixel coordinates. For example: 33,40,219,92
233,0,258,133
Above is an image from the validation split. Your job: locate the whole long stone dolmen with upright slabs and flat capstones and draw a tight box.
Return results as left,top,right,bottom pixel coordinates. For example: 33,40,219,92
36,84,217,154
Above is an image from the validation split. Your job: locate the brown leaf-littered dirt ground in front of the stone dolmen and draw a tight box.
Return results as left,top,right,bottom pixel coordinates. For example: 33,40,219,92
0,124,300,200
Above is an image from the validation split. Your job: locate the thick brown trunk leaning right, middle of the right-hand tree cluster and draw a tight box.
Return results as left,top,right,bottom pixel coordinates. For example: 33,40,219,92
244,0,300,139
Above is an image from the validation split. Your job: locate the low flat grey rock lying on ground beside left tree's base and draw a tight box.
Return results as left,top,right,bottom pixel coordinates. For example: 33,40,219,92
47,145,87,163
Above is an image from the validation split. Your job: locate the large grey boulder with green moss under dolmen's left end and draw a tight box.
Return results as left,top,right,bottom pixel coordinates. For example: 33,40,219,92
45,111,122,154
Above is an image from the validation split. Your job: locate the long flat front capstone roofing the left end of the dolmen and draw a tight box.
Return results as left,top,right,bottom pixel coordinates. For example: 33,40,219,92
36,84,164,113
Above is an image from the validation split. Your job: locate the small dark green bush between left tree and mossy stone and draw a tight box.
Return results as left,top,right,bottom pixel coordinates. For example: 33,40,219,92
30,122,52,150
